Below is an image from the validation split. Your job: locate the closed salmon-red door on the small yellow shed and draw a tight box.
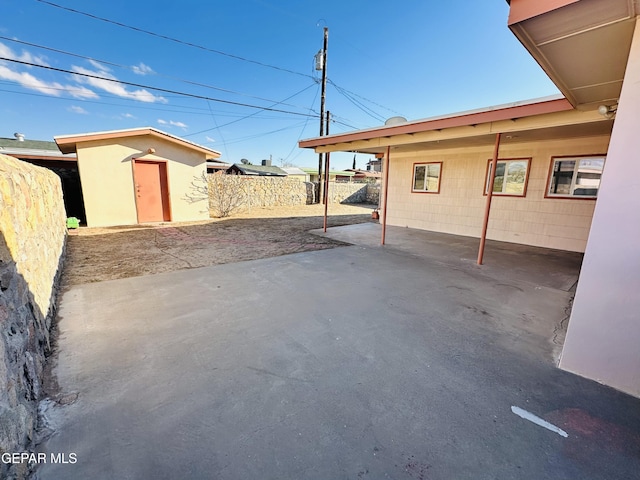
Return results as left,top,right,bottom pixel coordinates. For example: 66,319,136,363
133,160,171,223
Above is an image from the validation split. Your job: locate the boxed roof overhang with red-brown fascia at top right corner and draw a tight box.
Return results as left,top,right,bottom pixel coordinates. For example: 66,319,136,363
509,0,640,109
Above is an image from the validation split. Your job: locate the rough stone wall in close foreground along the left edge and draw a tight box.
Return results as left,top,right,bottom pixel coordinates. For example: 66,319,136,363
0,155,67,478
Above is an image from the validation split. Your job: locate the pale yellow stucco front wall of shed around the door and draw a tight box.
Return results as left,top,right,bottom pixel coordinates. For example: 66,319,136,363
77,136,209,227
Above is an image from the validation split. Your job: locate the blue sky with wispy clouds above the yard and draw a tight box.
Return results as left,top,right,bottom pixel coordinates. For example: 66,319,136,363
0,0,558,168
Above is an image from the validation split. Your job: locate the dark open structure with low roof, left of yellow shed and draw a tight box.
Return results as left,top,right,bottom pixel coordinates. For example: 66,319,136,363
0,133,86,222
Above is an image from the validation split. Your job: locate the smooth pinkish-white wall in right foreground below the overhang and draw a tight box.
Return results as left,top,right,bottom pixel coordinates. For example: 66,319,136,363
560,23,640,397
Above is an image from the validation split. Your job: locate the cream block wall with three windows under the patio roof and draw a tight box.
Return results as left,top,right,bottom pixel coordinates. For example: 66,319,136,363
387,137,609,252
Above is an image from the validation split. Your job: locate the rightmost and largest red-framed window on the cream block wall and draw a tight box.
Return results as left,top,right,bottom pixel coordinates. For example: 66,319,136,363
546,155,605,198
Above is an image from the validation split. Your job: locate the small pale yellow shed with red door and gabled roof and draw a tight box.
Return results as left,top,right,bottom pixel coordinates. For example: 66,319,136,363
54,127,220,227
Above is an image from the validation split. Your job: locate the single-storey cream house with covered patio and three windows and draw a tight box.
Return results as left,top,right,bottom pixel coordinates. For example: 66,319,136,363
300,0,640,396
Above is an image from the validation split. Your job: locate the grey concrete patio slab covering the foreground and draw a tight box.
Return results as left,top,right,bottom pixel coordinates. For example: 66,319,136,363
37,234,640,480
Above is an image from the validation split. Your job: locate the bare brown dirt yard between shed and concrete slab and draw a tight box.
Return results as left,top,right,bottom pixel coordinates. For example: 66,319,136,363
62,204,377,287
